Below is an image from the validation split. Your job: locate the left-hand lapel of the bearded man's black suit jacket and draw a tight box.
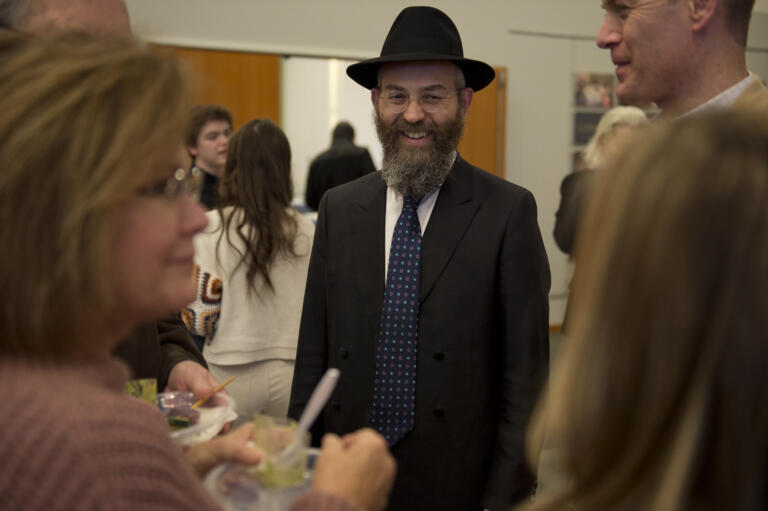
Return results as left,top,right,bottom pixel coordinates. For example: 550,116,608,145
351,178,387,337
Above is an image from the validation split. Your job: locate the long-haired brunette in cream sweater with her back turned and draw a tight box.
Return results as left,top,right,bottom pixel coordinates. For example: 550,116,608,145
185,119,314,420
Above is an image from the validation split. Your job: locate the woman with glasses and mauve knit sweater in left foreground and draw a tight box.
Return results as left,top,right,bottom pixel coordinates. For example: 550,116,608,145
0,31,394,511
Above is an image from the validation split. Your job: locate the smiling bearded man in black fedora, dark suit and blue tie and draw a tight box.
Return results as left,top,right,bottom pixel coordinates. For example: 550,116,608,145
289,7,550,511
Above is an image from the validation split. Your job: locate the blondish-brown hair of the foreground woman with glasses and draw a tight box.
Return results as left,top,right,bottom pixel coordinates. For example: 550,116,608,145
0,32,190,357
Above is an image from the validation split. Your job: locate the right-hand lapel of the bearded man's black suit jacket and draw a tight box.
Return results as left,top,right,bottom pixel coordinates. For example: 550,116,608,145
420,157,480,303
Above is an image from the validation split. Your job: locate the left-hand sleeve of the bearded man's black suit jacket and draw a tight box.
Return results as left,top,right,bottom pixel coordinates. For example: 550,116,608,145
288,194,328,445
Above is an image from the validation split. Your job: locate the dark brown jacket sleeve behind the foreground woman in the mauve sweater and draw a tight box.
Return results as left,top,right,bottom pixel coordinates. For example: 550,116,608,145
113,314,208,392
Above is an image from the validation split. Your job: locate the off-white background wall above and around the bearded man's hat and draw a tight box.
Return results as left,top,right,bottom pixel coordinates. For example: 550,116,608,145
127,0,768,323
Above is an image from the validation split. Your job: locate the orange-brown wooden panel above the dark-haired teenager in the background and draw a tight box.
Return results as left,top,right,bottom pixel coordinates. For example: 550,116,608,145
153,45,280,129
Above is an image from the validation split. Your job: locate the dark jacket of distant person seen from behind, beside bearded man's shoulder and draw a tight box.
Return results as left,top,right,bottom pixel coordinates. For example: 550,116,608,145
304,140,376,211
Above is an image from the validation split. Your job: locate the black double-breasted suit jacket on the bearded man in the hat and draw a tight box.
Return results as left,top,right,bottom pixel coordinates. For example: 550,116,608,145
289,158,550,511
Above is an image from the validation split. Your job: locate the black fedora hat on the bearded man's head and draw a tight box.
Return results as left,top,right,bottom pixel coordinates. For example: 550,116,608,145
347,7,496,91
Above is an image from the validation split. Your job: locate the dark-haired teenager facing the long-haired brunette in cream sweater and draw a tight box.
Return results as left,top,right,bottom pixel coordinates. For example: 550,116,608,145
186,105,232,210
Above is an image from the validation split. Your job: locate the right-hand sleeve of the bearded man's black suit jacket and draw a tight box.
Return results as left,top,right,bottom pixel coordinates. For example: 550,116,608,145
483,192,550,511
